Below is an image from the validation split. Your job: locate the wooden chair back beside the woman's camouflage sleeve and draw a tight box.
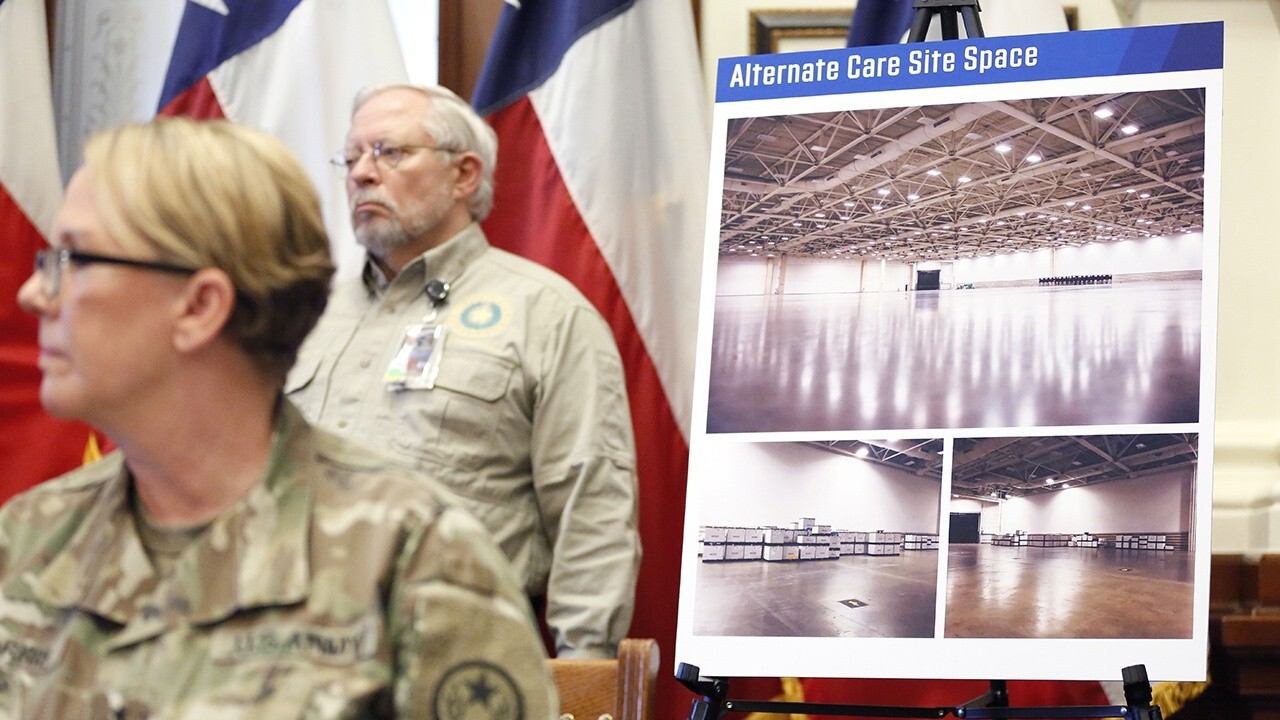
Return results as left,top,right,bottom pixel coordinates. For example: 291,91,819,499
550,638,658,720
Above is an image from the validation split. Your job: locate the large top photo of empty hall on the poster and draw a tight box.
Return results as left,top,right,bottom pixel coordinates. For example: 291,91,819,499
707,88,1212,433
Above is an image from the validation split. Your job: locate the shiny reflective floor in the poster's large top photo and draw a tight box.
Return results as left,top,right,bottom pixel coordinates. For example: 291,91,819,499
707,281,1202,433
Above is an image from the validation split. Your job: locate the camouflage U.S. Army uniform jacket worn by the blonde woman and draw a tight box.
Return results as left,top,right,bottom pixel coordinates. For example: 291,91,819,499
0,402,557,720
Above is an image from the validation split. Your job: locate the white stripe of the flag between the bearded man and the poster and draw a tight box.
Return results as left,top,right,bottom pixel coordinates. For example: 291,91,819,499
530,0,709,439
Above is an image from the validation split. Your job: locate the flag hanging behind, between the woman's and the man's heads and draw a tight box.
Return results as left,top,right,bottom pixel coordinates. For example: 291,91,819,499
153,0,407,274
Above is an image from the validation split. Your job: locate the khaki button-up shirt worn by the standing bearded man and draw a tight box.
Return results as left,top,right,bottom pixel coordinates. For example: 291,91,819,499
294,223,640,657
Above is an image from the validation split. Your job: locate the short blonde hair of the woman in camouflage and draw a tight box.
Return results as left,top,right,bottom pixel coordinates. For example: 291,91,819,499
84,118,334,386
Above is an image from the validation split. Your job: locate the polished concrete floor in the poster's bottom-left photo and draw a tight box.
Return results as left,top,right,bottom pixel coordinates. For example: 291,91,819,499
692,550,938,638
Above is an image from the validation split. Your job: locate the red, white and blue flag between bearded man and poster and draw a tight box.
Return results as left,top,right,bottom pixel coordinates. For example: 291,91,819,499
472,0,709,717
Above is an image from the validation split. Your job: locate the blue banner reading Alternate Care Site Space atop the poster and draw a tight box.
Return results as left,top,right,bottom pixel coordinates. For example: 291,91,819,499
716,22,1222,102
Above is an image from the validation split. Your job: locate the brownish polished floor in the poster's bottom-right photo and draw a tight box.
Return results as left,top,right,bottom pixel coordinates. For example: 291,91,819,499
945,544,1193,638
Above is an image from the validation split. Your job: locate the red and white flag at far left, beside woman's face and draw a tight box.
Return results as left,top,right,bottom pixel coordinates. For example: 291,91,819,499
0,0,102,501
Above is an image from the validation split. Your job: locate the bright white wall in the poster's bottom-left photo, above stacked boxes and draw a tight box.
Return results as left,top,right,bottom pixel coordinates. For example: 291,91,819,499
690,441,942,533
